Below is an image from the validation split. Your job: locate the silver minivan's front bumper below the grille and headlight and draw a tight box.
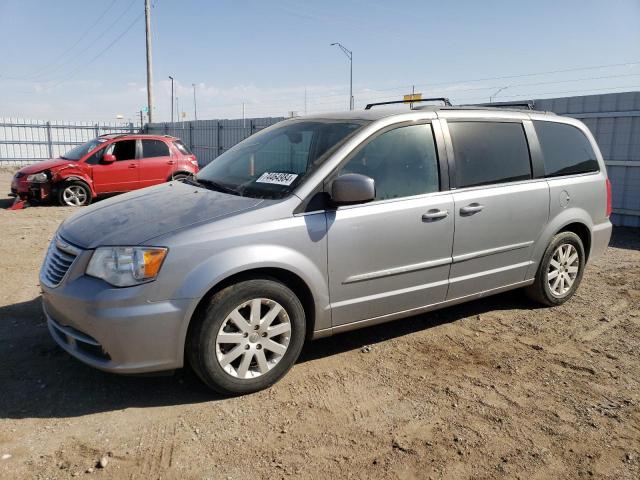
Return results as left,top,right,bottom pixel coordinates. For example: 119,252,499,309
41,276,193,373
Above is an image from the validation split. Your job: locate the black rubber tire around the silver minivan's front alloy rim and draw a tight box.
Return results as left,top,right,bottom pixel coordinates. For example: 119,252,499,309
189,279,306,395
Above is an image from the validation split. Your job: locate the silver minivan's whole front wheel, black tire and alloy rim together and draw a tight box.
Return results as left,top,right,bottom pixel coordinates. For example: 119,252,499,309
185,279,306,395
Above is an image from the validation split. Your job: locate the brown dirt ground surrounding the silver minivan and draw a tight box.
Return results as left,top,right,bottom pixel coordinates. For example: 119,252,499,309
0,172,640,480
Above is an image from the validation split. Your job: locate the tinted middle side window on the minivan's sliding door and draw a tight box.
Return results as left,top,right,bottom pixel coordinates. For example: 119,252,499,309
449,122,531,188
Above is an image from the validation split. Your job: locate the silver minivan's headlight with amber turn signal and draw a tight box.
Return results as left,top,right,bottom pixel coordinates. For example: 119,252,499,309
86,247,167,287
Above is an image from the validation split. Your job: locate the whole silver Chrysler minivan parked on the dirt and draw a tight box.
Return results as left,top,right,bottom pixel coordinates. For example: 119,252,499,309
40,100,611,394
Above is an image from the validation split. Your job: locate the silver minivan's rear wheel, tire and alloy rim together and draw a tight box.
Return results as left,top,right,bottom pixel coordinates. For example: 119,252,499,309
525,232,586,307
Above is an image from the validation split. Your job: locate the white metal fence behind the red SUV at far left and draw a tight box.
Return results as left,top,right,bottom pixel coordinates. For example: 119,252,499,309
0,118,137,166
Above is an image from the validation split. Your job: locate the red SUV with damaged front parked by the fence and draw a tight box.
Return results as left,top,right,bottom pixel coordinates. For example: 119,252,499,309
11,134,198,207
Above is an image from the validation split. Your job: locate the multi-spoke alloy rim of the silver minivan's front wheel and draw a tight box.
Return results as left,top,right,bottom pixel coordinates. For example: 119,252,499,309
216,298,291,380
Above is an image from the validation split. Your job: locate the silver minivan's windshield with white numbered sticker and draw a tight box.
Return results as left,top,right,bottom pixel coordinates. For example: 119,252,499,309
195,120,369,198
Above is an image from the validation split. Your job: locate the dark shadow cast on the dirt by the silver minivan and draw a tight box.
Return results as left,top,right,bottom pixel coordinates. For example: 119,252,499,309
0,292,535,419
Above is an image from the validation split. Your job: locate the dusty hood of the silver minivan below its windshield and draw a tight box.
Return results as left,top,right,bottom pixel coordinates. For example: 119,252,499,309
60,182,264,249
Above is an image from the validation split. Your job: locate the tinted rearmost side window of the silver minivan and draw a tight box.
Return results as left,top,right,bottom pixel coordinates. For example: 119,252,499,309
533,120,599,177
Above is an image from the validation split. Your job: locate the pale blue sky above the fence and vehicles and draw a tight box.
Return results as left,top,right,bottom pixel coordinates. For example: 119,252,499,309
0,0,640,121
